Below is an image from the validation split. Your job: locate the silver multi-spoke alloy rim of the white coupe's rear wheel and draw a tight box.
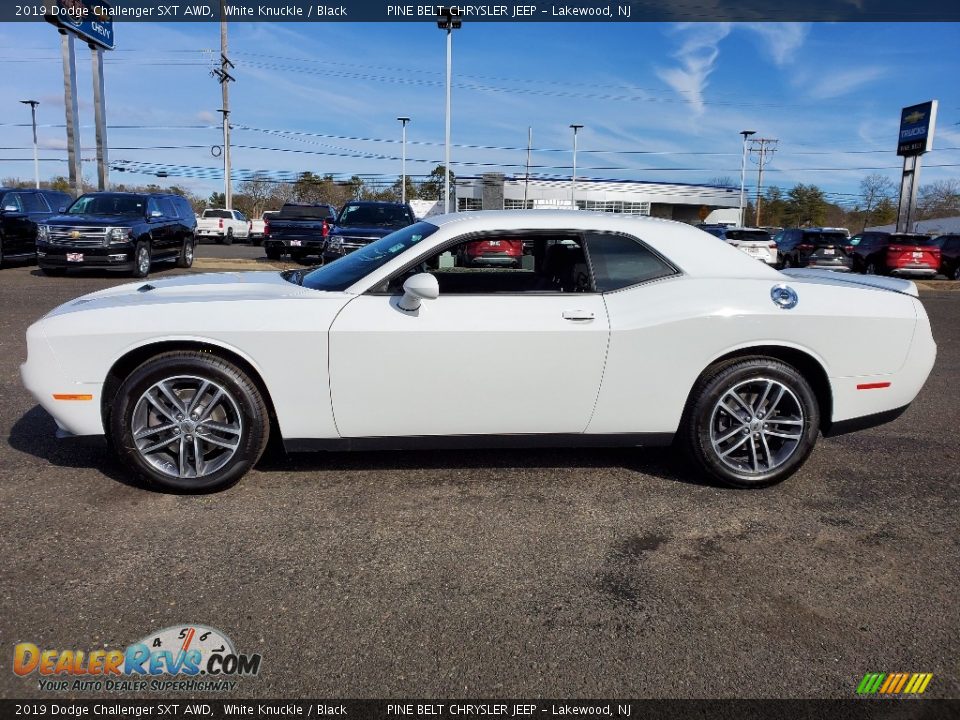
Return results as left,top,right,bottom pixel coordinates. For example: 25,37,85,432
710,377,805,475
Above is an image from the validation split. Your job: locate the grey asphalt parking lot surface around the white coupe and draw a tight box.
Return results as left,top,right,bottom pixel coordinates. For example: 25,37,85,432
0,246,960,698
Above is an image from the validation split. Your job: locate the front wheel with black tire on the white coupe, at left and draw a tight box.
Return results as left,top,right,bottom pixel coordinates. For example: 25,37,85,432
105,351,270,493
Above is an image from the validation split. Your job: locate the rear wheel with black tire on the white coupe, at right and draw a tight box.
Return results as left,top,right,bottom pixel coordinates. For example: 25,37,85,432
678,357,820,488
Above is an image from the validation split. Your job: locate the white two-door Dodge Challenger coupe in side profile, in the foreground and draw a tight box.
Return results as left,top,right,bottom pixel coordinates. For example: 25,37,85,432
22,211,936,492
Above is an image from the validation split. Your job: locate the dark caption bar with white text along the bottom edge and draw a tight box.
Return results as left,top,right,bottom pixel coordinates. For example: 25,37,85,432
0,697,960,720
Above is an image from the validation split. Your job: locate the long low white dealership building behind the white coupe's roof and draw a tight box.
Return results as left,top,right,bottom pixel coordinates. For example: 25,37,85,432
454,173,740,223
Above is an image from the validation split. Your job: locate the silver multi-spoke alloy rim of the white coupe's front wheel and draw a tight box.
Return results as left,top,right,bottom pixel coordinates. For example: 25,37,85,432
130,375,243,478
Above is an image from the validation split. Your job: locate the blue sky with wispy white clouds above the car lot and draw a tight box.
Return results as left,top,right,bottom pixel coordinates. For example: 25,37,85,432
0,22,960,202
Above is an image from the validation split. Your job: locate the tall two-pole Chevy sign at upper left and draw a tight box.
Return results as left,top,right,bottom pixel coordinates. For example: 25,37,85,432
46,0,114,195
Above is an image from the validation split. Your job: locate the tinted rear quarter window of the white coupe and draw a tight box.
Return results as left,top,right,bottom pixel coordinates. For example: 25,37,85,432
587,233,677,292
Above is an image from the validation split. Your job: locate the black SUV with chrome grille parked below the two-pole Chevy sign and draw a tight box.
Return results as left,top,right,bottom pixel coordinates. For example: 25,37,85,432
37,192,197,277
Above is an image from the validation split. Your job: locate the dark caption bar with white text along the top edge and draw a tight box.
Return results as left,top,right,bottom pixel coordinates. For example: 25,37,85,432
0,0,960,22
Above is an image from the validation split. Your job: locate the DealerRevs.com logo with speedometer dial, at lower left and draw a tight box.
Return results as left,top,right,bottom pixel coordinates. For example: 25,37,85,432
13,624,261,692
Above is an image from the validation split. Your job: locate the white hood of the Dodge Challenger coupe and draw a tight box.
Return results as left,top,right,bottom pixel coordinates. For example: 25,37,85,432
46,272,345,317
